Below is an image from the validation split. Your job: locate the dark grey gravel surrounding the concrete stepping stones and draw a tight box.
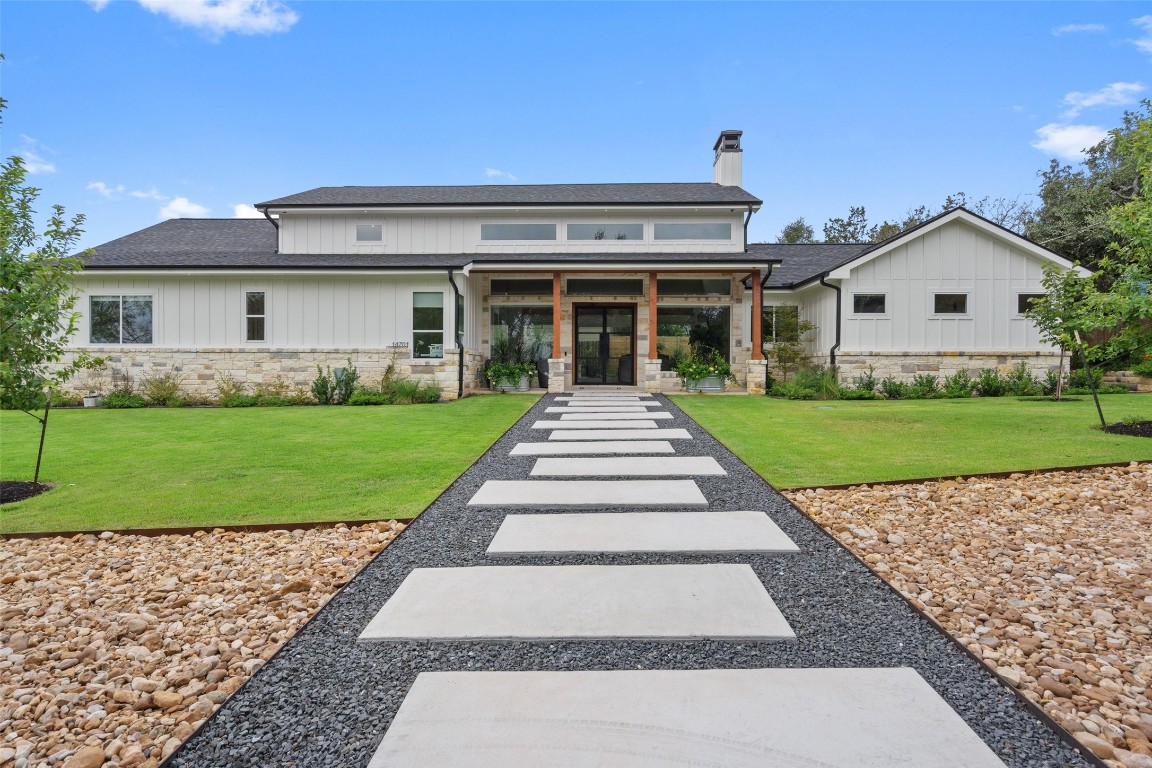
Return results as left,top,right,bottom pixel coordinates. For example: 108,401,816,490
165,396,1099,768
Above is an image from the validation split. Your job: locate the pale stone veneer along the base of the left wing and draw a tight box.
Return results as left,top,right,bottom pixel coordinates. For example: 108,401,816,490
52,347,479,400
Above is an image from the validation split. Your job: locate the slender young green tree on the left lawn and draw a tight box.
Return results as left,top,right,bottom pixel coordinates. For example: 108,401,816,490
0,128,103,482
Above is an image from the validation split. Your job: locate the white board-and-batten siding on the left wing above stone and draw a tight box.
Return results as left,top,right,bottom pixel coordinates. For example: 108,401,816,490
75,275,455,350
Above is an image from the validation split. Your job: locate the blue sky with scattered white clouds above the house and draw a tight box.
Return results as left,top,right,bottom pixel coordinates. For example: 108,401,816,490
0,0,1152,245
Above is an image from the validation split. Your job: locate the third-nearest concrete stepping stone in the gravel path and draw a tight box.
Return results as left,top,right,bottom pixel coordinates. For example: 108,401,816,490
487,511,799,555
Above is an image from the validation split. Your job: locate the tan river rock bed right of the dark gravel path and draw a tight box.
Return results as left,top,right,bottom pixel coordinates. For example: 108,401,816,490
786,464,1152,768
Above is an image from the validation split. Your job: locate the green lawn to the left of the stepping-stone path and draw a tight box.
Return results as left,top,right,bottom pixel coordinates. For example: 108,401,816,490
0,395,537,533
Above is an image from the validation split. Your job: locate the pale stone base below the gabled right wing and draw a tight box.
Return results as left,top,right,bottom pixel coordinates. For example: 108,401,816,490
823,351,1068,383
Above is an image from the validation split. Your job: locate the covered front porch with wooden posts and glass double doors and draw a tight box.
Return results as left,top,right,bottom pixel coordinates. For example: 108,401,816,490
470,263,772,394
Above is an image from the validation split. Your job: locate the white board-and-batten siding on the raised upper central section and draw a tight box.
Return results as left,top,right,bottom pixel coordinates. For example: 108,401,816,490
280,208,744,254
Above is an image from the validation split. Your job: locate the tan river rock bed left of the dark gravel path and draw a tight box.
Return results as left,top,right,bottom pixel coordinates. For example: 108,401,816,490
0,522,404,768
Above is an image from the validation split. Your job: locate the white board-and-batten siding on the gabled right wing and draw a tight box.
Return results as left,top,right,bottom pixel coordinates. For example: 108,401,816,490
843,222,1049,352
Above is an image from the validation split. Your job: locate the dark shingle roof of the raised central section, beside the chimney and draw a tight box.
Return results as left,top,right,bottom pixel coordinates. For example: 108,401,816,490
257,183,760,207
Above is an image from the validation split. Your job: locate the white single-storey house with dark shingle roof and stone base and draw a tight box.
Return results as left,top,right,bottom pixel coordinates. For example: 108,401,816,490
63,131,1071,398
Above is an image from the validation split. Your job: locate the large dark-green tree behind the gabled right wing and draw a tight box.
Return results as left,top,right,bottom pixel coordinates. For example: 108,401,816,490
1028,100,1152,271
